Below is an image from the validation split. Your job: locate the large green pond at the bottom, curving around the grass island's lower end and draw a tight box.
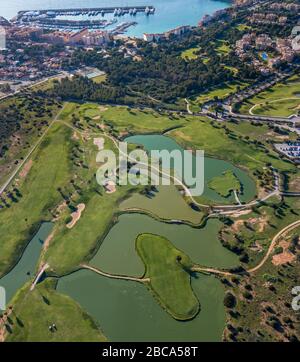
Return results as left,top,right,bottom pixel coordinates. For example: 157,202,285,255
57,270,225,342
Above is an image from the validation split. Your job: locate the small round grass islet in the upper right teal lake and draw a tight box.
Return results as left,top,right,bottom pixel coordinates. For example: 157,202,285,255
208,170,241,197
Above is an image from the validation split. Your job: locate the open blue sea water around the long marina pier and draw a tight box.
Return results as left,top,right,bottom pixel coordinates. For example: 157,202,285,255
0,0,229,37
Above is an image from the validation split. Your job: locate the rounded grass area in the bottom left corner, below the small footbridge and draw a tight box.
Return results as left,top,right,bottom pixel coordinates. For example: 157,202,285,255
6,280,106,342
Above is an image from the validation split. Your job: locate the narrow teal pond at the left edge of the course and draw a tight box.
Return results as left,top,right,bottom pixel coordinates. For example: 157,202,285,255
0,222,53,302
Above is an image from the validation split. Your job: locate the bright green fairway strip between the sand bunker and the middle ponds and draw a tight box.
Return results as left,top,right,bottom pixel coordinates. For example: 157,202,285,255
43,186,138,275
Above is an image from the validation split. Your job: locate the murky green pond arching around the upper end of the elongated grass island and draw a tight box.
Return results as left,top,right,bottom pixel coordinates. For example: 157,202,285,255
90,214,238,276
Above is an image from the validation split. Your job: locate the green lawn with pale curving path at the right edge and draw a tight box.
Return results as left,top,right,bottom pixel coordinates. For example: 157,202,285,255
239,76,300,117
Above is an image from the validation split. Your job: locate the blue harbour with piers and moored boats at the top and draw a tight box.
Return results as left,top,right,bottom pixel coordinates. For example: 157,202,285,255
1,0,229,38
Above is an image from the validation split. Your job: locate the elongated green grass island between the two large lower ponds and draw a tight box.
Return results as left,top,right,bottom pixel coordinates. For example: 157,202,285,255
136,234,200,320
